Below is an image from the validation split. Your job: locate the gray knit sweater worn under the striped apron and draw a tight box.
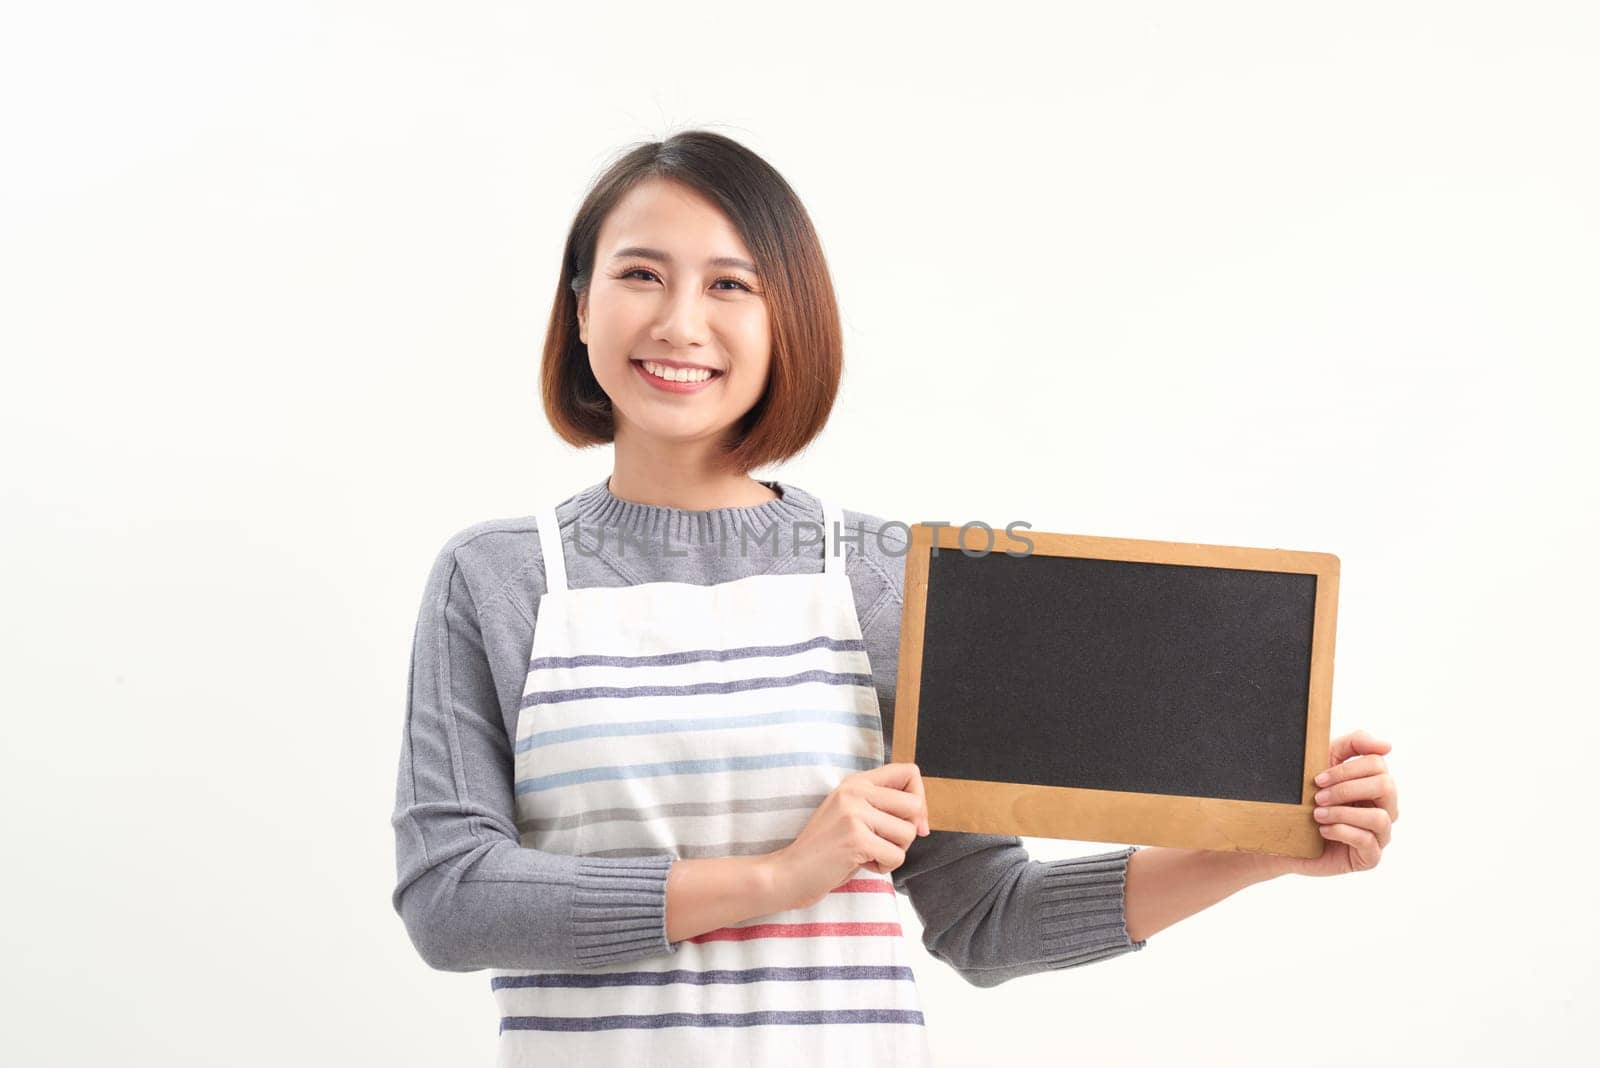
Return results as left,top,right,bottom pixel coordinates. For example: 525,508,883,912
392,480,1144,986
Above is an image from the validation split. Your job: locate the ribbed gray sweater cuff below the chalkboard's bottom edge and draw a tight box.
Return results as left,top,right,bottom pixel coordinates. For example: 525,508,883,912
1035,846,1144,969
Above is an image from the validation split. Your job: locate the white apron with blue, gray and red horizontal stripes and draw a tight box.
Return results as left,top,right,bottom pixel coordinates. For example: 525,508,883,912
491,502,931,1068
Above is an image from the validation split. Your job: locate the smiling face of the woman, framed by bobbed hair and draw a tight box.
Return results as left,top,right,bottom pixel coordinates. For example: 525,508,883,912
578,179,771,446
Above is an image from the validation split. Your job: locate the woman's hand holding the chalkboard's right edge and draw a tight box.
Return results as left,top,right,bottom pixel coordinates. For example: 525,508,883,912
1275,731,1400,875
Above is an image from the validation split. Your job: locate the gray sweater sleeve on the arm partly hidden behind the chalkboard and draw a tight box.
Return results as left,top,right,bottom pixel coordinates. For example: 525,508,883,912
862,524,1144,986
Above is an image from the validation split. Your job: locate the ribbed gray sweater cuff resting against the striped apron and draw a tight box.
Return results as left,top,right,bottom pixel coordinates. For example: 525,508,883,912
573,854,678,967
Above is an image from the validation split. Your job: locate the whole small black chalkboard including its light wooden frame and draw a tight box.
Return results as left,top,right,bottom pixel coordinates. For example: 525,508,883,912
893,524,1338,855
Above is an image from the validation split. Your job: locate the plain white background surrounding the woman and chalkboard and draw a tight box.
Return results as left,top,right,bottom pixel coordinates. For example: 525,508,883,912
0,0,1600,1066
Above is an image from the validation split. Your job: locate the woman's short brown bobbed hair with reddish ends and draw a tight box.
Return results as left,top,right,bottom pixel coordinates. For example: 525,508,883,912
541,130,843,475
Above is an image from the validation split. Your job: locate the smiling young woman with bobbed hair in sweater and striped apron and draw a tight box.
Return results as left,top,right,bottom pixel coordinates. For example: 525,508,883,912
394,131,1397,1068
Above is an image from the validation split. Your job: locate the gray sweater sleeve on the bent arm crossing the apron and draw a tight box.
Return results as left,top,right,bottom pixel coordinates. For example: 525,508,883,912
392,536,677,972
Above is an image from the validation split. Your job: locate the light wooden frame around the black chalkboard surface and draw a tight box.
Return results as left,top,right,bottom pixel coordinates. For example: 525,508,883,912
891,523,1339,857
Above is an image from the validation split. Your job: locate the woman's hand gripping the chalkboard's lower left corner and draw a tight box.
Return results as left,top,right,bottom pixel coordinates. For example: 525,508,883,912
766,764,928,908
